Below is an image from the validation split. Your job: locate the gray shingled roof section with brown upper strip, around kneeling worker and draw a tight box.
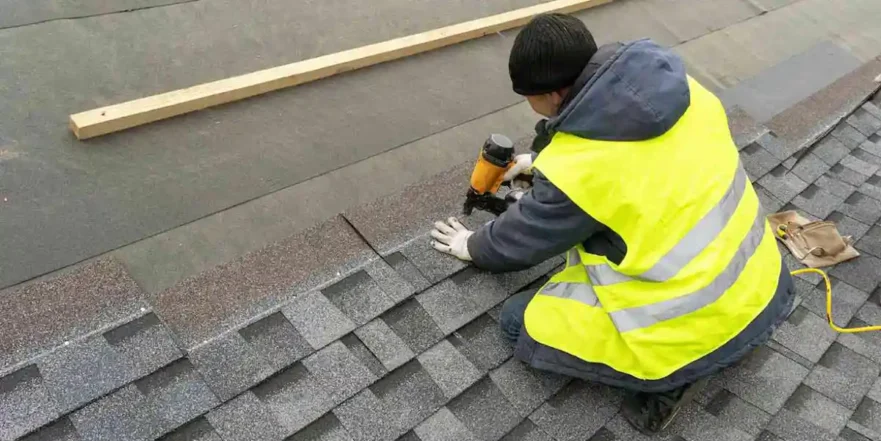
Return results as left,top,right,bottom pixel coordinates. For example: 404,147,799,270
0,63,881,441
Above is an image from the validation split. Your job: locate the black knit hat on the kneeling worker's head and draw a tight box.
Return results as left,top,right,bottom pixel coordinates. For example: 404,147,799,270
508,14,597,95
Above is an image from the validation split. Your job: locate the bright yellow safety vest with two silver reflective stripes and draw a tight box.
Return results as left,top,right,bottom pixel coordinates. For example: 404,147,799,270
525,78,781,380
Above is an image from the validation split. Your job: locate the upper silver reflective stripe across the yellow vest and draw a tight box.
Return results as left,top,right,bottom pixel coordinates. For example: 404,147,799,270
587,164,744,286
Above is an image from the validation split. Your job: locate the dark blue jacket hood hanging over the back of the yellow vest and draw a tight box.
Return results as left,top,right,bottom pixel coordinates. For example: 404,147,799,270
548,40,691,141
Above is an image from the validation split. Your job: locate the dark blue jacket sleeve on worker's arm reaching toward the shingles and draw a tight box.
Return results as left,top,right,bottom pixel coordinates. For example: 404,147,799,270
468,170,606,272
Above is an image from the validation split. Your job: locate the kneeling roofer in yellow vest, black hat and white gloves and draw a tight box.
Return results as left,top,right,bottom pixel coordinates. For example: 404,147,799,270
432,14,794,434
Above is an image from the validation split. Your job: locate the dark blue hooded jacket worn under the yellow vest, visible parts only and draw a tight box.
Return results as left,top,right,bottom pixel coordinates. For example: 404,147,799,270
468,40,795,392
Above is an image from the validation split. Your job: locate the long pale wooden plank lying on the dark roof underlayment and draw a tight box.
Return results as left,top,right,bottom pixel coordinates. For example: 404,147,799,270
70,0,613,139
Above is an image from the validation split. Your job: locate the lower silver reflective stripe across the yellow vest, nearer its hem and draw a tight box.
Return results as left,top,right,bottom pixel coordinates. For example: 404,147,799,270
539,199,766,332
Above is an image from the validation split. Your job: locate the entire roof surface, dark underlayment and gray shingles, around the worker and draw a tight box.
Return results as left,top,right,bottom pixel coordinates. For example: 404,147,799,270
0,0,881,441
